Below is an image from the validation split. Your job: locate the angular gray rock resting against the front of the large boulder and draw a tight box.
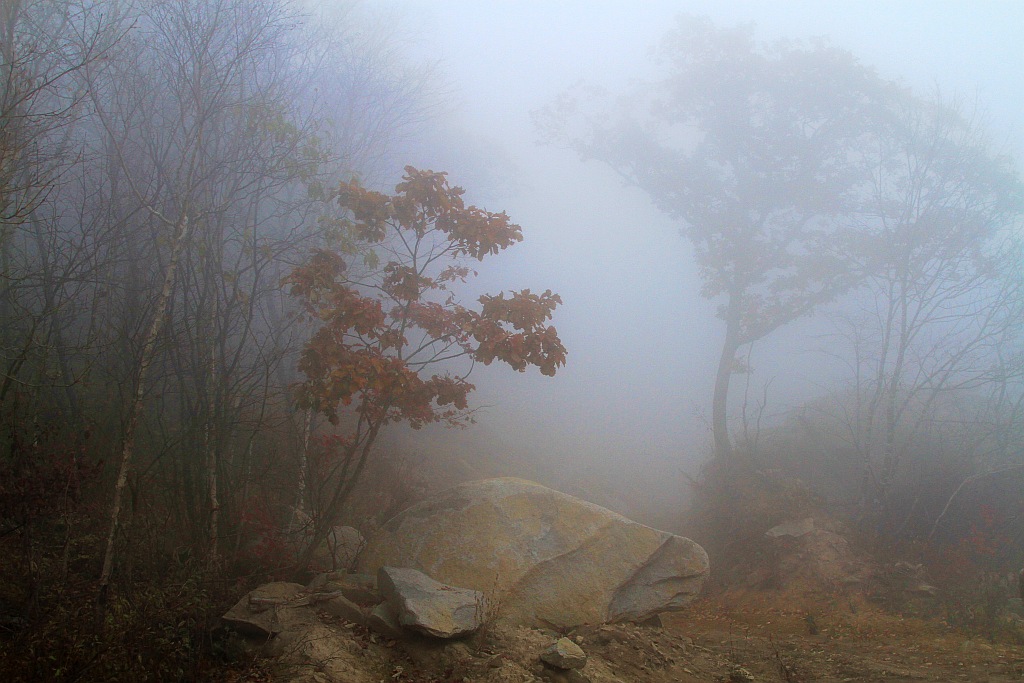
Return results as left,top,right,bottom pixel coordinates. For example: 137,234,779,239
377,566,486,638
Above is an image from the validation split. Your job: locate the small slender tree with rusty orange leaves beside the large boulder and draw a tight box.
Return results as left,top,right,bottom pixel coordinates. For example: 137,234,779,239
285,167,565,568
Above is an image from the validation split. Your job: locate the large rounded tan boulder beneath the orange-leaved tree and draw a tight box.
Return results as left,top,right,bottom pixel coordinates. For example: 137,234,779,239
359,478,709,629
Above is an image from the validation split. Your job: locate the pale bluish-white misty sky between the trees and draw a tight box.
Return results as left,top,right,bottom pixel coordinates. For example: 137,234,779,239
364,0,1024,511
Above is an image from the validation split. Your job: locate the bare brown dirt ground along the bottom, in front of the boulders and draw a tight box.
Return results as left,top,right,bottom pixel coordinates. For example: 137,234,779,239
218,591,1024,683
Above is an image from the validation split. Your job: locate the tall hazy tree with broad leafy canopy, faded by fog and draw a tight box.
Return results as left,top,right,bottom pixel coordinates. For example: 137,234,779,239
537,17,1010,457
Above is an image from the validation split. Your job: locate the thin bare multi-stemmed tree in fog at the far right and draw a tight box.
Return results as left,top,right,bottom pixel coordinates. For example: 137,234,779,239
827,93,1024,528
